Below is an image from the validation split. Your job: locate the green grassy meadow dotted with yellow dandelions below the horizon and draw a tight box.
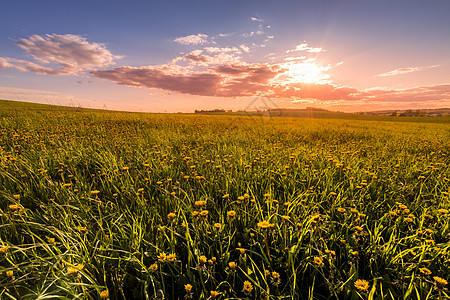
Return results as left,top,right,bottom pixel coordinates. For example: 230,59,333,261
0,103,450,299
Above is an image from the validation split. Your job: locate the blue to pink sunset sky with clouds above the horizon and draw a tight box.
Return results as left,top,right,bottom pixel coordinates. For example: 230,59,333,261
0,0,450,113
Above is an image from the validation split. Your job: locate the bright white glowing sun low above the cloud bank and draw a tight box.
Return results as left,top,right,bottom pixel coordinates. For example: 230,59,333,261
285,62,329,84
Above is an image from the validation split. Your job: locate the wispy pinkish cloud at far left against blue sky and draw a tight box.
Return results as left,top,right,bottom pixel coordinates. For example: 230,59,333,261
0,34,122,75
